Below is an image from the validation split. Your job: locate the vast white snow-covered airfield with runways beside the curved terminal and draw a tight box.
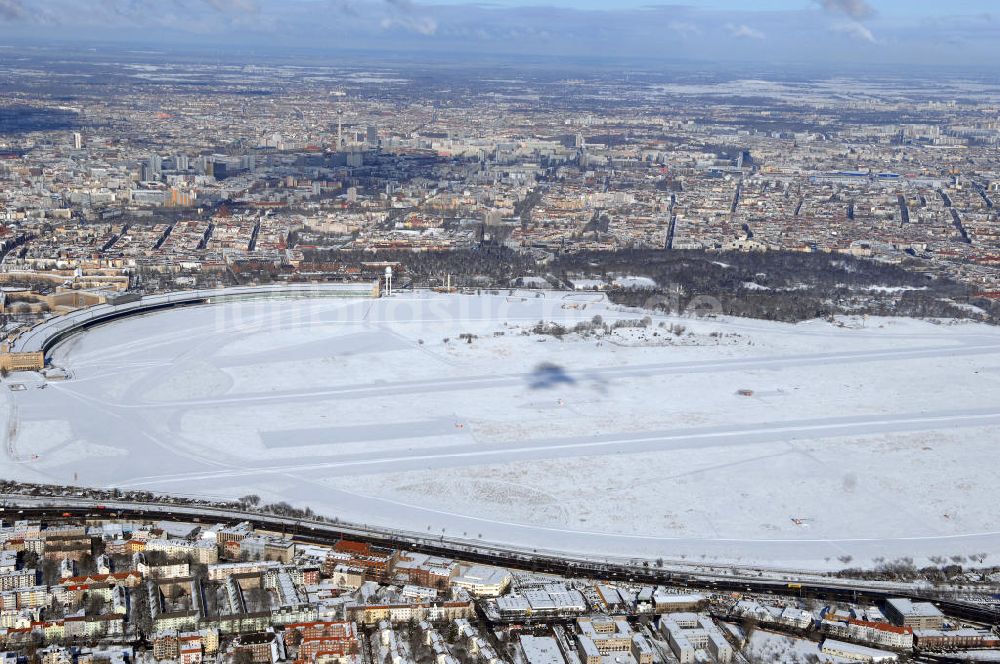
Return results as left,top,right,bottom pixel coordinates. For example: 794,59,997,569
0,292,1000,568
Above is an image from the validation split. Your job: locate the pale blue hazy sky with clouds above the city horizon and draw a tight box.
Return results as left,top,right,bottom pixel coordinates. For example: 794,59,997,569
0,0,1000,67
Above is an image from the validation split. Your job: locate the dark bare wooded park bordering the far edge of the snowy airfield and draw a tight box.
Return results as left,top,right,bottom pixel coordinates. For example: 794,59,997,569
310,246,1000,324
